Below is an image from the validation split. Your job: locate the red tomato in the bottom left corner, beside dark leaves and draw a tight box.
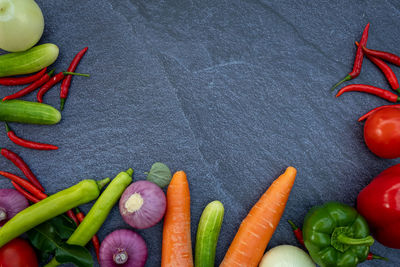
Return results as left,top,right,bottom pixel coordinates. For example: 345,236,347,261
0,238,39,267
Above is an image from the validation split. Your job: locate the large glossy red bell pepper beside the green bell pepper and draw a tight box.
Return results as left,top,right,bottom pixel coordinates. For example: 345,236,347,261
357,164,400,249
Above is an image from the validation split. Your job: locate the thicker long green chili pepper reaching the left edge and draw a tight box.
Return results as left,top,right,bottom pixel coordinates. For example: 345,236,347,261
0,178,110,247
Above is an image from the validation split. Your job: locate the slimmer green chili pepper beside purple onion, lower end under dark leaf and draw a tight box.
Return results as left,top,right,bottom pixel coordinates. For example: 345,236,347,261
45,169,133,267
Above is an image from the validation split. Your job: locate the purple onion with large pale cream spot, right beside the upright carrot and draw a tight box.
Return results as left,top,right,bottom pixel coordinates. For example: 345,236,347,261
119,181,167,229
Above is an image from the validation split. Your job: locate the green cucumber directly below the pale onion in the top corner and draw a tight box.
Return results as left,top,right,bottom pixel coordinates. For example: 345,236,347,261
0,44,59,77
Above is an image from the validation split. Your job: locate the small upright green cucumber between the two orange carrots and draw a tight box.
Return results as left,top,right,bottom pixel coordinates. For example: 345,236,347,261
194,200,224,267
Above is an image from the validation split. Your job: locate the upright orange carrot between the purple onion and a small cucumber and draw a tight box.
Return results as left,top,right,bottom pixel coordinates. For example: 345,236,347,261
161,171,193,267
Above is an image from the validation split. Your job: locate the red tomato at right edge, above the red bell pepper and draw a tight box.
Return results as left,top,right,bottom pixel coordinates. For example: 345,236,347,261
364,107,400,159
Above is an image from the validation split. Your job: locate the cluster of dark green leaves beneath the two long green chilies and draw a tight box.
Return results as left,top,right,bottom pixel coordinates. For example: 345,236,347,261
27,215,93,267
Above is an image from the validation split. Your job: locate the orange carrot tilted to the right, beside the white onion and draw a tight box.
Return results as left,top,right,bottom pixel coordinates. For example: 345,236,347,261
220,167,297,267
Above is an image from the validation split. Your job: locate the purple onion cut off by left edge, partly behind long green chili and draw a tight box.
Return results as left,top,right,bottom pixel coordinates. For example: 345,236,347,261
0,189,29,226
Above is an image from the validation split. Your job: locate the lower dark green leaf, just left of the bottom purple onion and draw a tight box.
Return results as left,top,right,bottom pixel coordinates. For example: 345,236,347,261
56,243,93,267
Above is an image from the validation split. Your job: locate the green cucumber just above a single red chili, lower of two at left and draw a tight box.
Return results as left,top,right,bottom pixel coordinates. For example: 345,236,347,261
0,100,61,124
